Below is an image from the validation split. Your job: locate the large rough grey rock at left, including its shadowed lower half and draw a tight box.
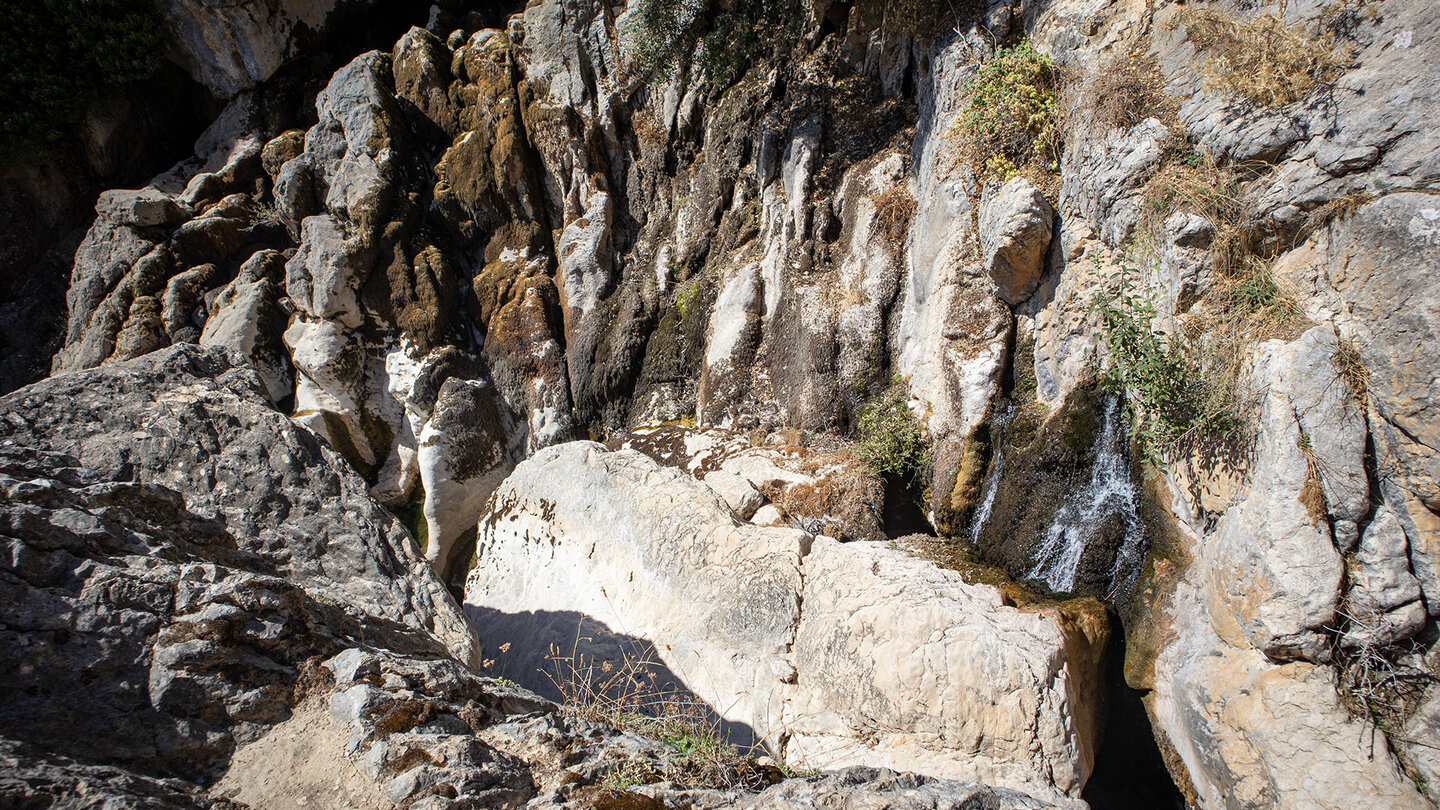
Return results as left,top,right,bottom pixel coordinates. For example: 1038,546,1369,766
0,344,477,790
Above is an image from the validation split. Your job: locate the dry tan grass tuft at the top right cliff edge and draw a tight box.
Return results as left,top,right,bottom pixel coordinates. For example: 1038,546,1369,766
1176,9,1354,107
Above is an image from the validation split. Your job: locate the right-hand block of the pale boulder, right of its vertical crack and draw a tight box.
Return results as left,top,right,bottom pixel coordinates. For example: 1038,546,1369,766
785,538,1106,803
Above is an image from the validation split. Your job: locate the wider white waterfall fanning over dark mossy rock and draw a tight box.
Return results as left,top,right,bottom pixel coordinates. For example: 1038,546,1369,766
1025,396,1145,597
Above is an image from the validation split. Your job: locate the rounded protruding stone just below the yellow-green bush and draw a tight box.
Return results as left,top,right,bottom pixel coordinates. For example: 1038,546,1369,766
979,177,1056,307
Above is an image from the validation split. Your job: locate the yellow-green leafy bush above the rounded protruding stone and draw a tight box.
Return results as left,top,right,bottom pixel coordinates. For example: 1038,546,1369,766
952,42,1060,180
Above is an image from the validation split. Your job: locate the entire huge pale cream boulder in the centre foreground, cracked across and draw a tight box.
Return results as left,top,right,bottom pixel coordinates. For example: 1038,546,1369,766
465,442,1107,806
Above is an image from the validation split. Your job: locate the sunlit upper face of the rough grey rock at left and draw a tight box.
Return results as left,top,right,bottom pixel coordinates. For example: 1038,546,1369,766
0,344,472,660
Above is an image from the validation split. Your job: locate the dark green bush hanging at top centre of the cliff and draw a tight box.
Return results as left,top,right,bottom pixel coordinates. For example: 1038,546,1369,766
621,0,801,91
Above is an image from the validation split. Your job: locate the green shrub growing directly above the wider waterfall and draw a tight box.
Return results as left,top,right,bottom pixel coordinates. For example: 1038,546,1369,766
1090,267,1238,464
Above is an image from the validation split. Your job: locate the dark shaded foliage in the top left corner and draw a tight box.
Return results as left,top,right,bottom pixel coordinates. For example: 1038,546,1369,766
0,0,163,153
